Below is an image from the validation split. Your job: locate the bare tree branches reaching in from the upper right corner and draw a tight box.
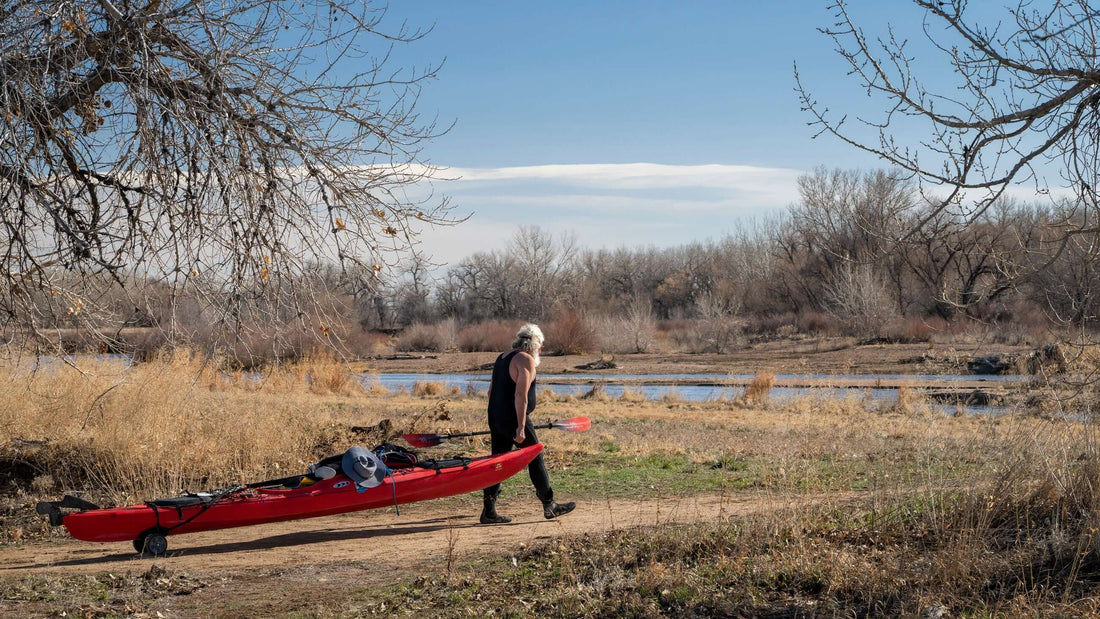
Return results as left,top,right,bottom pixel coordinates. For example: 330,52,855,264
795,0,1100,283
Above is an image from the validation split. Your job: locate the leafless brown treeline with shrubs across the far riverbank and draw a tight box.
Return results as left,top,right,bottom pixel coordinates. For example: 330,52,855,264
25,169,1100,356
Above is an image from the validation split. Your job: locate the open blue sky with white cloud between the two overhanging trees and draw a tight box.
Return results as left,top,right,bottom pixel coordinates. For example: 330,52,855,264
371,0,981,269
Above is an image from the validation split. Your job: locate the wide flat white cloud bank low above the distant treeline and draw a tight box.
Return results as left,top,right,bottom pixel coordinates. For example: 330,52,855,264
409,163,802,270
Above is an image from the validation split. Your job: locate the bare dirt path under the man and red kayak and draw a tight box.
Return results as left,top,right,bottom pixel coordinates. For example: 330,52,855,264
0,496,787,578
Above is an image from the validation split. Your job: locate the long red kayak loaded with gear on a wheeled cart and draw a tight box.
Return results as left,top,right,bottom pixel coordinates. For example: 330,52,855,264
39,444,542,555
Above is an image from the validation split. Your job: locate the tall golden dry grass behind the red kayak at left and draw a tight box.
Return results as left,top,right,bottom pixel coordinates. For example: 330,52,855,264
0,351,381,502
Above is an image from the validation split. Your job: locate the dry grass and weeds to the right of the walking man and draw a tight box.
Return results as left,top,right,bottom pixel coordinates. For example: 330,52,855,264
349,394,1100,616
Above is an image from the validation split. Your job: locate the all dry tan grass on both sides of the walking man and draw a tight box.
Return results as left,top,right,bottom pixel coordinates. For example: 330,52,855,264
0,354,1100,616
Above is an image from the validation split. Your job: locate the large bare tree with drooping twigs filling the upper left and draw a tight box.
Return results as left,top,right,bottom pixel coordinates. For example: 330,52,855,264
0,0,448,349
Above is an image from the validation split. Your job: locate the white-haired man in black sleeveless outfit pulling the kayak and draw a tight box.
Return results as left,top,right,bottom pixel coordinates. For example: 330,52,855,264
481,324,576,524
